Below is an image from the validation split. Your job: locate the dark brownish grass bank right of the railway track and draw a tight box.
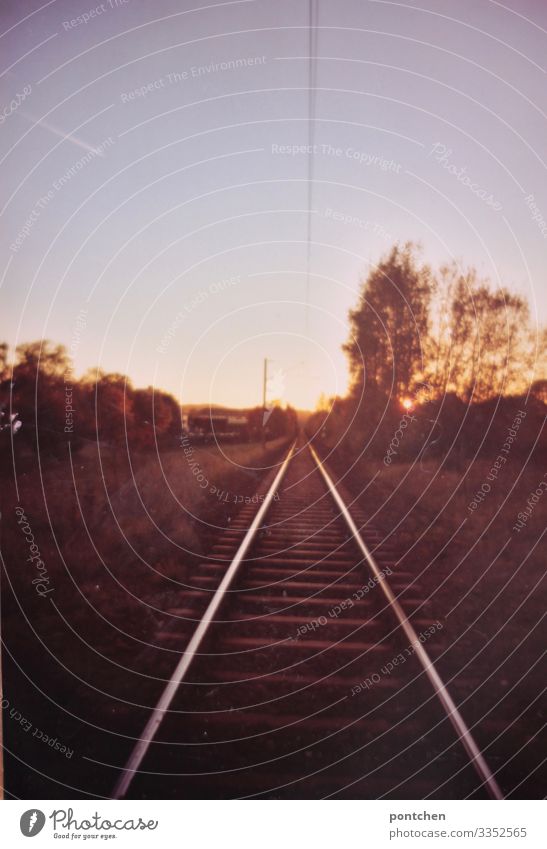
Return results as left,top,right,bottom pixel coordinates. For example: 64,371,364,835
333,444,547,798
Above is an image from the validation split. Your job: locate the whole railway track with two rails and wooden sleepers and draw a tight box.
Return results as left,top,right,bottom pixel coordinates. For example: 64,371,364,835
113,443,502,799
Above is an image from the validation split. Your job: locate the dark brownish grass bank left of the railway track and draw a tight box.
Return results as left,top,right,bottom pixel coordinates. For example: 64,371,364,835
2,434,294,798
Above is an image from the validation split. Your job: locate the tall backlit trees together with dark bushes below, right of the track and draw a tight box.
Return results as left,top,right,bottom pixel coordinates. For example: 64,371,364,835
307,238,547,464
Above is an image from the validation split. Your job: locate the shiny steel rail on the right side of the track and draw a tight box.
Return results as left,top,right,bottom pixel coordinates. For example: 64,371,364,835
308,443,504,799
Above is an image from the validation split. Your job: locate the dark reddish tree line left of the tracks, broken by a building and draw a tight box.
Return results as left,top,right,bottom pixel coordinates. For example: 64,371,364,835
0,340,294,454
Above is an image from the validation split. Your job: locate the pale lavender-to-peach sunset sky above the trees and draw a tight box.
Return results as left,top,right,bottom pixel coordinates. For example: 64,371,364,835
0,0,547,408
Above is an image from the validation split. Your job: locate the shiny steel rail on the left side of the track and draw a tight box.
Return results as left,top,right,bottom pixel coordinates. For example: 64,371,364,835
112,440,296,799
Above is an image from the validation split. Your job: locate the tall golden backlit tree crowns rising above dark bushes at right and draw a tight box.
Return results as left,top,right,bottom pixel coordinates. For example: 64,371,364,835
344,243,547,403
